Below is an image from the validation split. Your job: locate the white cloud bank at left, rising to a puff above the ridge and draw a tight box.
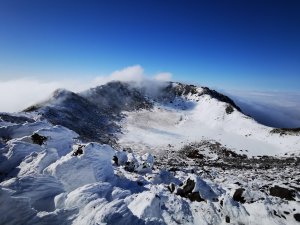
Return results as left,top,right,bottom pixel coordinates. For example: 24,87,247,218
0,65,172,112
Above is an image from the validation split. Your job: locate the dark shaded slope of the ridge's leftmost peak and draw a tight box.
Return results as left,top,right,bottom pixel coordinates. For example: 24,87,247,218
24,90,119,143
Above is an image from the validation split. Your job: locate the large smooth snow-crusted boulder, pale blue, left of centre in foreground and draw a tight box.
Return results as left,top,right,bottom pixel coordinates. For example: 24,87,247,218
44,143,115,191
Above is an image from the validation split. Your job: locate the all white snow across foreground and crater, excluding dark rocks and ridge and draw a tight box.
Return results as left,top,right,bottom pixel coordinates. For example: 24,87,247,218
0,83,300,225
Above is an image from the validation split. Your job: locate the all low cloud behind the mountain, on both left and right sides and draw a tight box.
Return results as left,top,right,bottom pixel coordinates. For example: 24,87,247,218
0,65,300,127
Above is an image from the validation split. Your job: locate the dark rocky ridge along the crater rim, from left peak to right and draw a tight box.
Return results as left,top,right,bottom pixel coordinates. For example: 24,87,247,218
23,81,245,144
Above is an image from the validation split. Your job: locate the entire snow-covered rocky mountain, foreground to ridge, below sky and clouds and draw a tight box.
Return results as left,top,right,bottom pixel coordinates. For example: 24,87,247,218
0,82,300,225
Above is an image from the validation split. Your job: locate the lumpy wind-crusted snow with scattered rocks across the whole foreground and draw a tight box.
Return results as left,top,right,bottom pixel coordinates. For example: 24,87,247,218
0,117,300,225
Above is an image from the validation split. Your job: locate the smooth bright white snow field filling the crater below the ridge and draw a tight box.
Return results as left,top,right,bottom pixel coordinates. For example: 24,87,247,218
119,85,300,156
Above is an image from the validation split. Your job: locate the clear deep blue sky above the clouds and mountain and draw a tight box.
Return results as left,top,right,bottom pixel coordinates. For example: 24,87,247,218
0,0,300,91
